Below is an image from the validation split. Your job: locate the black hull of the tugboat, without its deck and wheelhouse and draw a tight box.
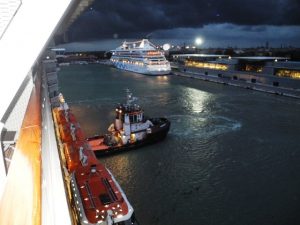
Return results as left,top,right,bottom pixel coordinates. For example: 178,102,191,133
87,118,171,156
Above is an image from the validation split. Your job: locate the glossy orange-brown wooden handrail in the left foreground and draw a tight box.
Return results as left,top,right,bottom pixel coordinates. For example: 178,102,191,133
0,76,41,225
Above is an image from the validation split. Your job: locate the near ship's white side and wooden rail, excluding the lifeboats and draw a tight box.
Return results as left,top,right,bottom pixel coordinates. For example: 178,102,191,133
0,0,93,225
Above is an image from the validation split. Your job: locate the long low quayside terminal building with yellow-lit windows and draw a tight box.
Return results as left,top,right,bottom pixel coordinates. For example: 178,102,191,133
172,54,300,97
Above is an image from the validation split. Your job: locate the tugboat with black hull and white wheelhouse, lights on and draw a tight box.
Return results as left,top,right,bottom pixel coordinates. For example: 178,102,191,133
87,89,170,155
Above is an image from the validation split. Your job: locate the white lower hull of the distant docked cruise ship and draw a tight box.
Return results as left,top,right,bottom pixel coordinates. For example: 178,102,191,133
113,62,171,76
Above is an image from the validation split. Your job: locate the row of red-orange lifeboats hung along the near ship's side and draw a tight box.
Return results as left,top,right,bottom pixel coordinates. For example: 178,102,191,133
53,95,137,225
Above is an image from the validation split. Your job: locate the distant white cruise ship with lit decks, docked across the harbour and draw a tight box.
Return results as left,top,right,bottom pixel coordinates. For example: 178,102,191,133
110,39,171,75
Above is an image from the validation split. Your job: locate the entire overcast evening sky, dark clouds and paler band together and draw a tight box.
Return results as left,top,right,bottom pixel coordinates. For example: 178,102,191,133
69,0,300,47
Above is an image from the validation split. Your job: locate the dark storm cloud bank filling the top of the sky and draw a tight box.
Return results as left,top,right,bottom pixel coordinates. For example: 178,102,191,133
69,0,300,40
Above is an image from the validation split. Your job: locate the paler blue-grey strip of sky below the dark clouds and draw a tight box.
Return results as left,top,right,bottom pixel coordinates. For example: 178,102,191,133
58,23,300,51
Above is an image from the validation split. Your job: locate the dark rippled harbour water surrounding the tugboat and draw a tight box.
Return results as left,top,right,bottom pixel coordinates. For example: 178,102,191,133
58,64,300,225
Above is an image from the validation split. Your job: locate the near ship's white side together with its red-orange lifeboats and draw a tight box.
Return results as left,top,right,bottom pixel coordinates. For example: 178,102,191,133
0,0,136,225
